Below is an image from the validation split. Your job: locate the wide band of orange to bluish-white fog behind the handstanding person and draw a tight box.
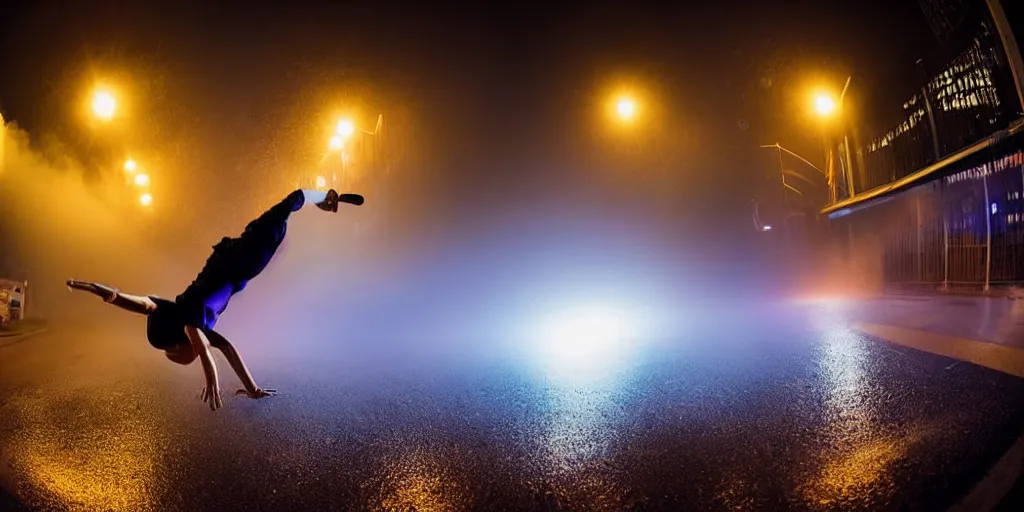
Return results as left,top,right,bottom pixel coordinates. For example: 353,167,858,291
0,101,880,366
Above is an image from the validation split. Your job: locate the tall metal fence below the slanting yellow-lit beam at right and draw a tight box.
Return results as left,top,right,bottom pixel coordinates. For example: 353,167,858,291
831,132,1024,290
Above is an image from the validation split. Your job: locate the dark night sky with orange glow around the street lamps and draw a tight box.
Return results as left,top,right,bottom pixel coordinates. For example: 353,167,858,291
0,0,936,284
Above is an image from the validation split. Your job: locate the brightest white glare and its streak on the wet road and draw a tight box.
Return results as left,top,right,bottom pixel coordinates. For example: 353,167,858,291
535,304,647,510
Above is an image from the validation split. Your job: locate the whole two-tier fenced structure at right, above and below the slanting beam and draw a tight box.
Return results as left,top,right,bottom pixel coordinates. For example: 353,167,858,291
825,0,1024,291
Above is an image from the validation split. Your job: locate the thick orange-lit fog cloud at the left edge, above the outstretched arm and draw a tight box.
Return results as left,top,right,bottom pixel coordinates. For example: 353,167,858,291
0,117,185,319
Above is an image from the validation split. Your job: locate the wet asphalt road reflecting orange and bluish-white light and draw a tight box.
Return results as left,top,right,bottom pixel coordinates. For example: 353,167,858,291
0,301,1024,511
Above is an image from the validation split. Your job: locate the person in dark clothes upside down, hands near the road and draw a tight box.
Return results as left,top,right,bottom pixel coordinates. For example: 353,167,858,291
68,189,362,411
